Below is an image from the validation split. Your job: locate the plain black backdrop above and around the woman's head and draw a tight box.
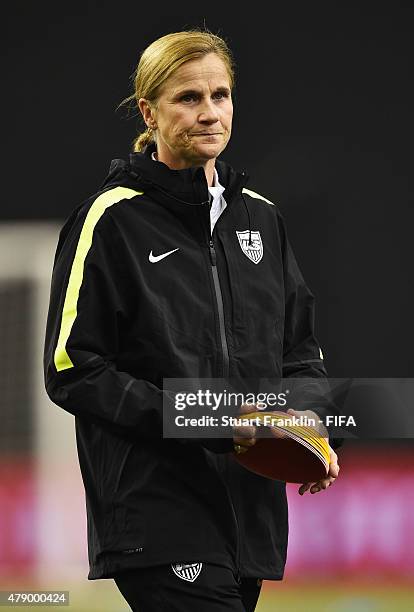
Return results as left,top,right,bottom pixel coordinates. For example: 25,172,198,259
0,1,414,377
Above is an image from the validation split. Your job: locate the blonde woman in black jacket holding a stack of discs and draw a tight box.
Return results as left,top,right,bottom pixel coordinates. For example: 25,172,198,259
45,31,338,612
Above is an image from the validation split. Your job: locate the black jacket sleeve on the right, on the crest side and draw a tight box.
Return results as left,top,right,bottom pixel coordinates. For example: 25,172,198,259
279,213,342,448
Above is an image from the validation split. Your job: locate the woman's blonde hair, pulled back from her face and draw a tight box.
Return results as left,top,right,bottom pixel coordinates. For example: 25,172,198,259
120,30,235,151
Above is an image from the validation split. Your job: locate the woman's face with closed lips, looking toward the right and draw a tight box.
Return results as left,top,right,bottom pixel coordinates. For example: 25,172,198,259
140,53,233,169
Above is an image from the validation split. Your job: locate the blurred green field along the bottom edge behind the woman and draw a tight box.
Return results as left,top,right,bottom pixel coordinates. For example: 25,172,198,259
1,580,414,612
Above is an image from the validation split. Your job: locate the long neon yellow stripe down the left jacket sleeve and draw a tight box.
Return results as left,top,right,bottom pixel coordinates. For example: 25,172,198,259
55,187,143,372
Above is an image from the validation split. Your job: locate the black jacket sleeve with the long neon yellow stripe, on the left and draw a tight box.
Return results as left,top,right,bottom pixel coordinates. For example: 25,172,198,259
44,198,230,452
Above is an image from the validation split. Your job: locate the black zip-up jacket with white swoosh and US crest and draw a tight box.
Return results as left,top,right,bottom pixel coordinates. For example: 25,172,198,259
44,143,338,579
